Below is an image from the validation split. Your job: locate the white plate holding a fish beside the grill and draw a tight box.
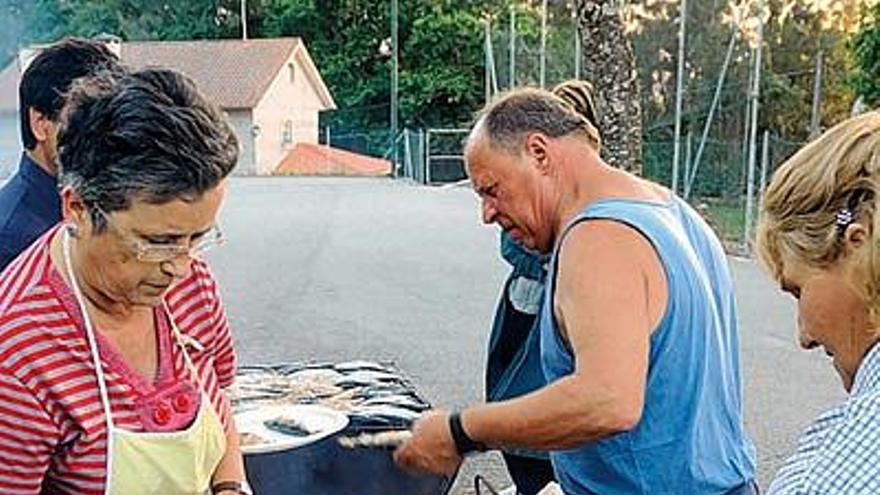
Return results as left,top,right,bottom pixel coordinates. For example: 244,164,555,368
235,405,348,454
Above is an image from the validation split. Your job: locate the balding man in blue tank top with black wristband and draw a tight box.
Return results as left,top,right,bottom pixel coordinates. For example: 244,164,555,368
395,89,757,495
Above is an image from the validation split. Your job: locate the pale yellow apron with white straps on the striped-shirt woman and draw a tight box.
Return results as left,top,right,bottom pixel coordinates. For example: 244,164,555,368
62,229,226,495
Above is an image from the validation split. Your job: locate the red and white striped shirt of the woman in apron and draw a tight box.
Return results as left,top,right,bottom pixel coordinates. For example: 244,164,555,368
0,227,235,495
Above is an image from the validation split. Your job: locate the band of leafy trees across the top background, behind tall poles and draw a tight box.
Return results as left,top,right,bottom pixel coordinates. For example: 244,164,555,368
0,0,868,155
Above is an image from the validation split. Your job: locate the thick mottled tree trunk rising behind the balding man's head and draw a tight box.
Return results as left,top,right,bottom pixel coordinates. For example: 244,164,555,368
577,0,642,174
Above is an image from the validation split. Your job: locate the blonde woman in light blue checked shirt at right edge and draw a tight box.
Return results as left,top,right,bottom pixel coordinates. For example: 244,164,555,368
757,112,880,495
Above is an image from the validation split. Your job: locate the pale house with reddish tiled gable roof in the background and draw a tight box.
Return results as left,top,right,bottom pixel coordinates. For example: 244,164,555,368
0,38,336,175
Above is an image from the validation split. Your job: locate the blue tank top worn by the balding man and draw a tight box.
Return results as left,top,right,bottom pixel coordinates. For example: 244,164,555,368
540,198,755,495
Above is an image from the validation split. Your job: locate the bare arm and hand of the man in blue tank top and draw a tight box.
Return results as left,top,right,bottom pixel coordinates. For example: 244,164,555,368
397,221,667,472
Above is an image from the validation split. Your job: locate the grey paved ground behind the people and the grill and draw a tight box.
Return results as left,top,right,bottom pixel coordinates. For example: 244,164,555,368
211,178,843,494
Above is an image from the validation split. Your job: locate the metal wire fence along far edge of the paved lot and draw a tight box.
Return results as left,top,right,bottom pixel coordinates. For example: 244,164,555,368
325,115,804,253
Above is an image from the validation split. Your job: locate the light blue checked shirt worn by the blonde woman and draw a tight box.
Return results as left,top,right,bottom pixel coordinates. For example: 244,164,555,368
767,344,880,495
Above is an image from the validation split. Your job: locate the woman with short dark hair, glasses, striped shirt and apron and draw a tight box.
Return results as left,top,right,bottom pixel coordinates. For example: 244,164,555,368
0,70,246,495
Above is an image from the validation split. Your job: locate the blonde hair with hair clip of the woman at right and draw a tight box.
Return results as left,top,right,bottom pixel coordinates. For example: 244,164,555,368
757,112,880,313
